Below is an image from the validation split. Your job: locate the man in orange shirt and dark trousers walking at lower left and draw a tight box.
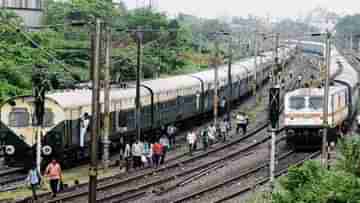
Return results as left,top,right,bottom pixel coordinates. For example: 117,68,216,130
45,158,62,197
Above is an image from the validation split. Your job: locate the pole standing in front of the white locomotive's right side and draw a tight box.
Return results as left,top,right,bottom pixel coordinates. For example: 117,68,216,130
322,31,331,168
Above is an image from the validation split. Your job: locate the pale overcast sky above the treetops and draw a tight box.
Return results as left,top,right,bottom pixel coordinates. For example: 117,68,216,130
122,0,360,18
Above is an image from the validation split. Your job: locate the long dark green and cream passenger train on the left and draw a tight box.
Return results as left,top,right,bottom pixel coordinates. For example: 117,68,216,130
0,45,295,169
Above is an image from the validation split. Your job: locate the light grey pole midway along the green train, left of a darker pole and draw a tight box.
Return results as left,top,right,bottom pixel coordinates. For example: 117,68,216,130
214,38,219,126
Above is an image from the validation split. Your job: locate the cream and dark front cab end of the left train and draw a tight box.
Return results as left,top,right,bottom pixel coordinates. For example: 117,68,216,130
0,96,63,167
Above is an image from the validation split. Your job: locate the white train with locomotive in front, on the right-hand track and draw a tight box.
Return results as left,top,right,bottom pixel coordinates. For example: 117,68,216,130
283,41,359,149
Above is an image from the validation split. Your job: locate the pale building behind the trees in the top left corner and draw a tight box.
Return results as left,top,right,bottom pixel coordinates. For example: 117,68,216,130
0,0,43,28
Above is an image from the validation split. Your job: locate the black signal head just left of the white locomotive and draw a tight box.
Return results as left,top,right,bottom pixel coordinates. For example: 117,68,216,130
269,85,280,128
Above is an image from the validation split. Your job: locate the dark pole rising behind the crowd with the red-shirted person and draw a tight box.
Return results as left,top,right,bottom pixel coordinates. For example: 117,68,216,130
135,30,143,141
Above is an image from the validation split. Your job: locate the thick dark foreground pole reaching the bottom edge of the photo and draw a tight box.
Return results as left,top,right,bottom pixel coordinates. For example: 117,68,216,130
89,19,101,203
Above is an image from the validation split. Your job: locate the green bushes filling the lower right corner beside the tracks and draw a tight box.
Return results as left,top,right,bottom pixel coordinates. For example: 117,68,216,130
272,136,360,203
